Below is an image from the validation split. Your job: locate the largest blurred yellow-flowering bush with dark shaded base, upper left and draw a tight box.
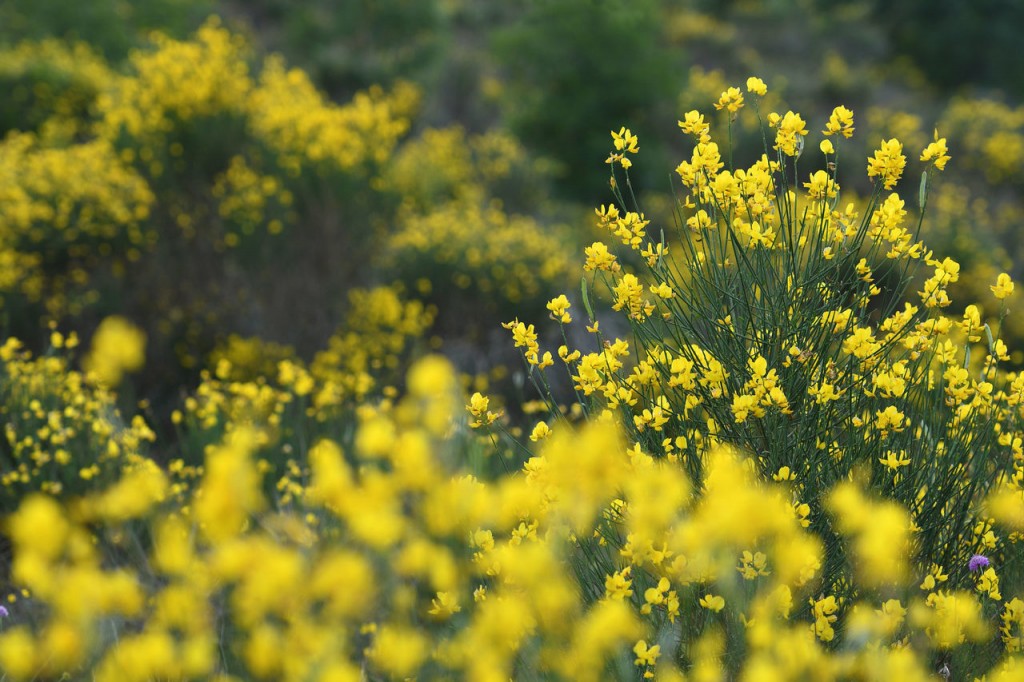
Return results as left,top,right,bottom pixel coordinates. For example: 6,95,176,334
0,18,428,376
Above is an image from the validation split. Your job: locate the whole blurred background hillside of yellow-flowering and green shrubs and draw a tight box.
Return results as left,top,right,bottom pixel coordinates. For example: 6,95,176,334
0,0,1024,423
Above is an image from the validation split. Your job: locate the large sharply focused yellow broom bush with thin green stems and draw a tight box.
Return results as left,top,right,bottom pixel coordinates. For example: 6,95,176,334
499,78,1024,674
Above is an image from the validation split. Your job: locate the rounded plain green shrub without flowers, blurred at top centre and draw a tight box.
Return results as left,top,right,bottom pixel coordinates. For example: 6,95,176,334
494,0,682,202
